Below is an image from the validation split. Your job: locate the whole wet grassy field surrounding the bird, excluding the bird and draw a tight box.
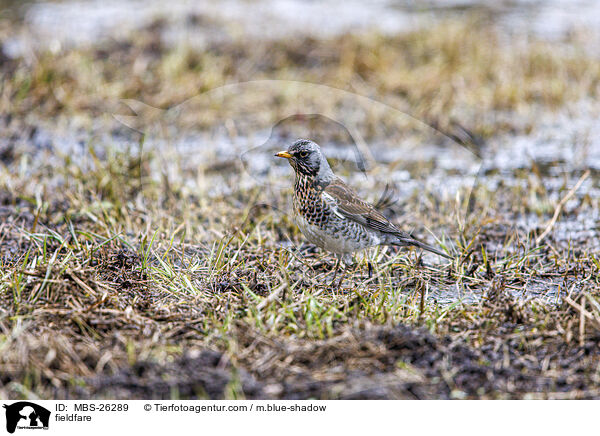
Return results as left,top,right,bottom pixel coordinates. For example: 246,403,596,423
0,2,600,399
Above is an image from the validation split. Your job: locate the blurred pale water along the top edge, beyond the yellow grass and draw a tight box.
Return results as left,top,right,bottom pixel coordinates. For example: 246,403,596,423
4,0,600,57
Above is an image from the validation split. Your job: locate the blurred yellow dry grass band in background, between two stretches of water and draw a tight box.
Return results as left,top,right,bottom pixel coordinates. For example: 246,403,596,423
0,18,600,136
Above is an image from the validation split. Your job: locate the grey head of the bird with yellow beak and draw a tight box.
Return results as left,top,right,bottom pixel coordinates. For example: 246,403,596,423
275,139,333,181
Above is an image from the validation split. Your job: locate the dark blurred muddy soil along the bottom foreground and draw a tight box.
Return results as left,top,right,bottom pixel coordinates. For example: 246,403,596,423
61,302,600,399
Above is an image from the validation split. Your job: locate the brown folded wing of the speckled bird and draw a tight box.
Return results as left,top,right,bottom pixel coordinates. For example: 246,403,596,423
323,178,408,236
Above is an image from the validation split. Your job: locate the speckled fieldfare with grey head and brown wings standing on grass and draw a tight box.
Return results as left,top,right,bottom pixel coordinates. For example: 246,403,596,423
275,139,453,280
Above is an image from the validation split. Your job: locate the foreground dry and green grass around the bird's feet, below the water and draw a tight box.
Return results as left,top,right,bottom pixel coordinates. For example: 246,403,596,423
0,127,600,398
